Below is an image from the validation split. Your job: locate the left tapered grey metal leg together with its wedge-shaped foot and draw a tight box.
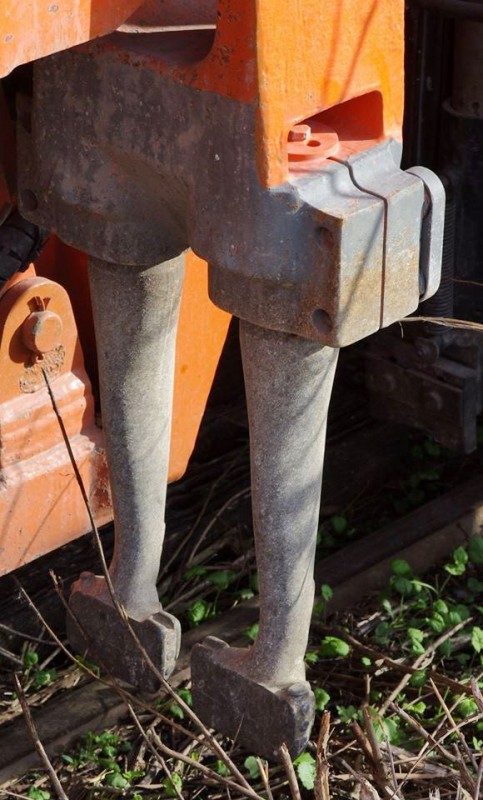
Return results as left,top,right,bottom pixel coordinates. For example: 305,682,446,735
69,256,184,689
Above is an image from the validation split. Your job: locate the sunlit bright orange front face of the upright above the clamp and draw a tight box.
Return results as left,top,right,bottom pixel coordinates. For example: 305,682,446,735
257,0,404,185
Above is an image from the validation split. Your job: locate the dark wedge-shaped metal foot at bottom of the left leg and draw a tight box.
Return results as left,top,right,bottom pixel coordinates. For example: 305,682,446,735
67,572,181,692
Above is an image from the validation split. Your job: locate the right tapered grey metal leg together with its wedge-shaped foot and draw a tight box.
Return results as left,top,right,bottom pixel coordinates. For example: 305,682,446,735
191,322,338,758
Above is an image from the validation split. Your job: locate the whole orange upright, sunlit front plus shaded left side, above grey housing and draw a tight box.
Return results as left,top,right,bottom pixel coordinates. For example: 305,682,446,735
170,0,404,186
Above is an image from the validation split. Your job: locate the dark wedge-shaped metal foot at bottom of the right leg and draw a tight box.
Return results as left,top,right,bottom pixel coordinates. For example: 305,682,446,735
191,636,314,760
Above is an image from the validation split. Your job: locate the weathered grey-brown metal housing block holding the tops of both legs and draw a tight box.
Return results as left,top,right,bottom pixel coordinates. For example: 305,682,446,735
20,31,436,347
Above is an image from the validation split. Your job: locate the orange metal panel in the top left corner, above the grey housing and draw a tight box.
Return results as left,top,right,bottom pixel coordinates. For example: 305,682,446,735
0,0,141,77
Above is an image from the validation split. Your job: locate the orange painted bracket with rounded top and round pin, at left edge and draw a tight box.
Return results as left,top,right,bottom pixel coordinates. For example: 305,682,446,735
0,277,111,574
